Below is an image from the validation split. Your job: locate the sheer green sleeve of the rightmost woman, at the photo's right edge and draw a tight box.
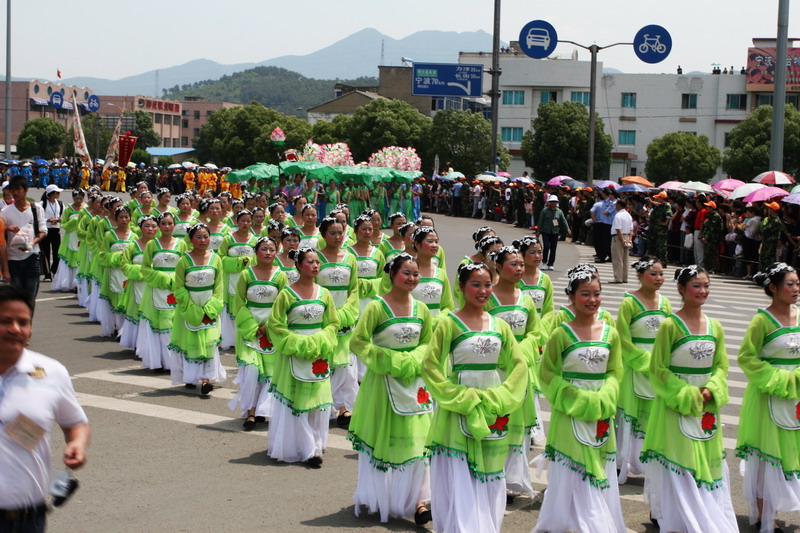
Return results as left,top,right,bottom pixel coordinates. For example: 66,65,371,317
739,313,800,399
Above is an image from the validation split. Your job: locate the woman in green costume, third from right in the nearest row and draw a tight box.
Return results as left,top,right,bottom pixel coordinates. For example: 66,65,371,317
533,265,627,533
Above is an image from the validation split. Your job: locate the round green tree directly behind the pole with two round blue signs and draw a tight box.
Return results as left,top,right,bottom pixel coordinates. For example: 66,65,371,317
522,102,613,180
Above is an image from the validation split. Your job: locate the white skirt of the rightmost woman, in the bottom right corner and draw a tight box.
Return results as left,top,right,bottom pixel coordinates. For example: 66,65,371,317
740,455,800,533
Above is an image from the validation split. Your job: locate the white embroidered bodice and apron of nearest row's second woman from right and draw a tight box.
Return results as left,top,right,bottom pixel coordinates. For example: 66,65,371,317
669,315,719,441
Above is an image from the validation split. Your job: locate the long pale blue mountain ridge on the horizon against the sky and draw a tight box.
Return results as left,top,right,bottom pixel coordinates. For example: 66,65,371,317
51,28,492,96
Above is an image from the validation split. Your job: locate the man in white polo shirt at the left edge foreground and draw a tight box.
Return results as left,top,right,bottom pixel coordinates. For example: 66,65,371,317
0,284,90,533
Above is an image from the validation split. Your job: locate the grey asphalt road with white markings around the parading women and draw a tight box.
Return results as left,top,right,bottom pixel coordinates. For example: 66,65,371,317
26,198,800,533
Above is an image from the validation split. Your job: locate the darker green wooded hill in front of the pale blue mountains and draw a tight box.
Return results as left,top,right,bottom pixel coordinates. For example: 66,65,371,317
164,67,378,116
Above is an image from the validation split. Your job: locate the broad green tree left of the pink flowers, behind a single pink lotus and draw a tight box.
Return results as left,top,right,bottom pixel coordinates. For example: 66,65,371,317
194,102,311,168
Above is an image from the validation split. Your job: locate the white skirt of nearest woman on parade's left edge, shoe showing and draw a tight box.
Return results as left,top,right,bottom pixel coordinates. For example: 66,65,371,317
353,452,431,523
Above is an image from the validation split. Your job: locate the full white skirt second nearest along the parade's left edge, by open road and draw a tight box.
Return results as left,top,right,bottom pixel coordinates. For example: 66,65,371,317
267,400,330,463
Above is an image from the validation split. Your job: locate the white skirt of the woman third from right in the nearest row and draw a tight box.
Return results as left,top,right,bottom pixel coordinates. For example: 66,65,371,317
533,461,628,533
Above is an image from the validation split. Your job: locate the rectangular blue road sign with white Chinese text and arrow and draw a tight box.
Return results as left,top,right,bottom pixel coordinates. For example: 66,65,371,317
411,63,483,98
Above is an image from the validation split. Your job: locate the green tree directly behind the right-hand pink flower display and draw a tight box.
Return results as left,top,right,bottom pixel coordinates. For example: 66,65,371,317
350,98,431,161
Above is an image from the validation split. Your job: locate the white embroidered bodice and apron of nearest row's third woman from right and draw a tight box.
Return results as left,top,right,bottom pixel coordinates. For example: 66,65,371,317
561,322,613,448
